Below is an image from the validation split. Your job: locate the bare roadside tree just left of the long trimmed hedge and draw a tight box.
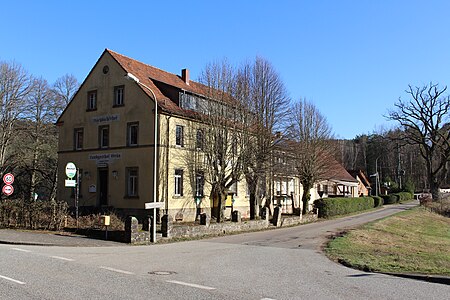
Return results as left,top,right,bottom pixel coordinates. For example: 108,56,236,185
289,99,334,214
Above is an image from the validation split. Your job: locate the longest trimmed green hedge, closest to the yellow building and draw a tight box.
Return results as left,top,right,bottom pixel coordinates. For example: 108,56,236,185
314,197,375,218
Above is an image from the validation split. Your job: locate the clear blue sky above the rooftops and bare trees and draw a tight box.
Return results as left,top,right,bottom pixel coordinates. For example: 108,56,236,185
0,0,450,139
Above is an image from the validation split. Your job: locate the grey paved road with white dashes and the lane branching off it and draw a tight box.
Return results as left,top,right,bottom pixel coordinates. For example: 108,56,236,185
0,206,450,300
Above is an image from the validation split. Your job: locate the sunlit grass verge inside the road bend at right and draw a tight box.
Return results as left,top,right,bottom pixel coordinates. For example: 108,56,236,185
325,208,450,276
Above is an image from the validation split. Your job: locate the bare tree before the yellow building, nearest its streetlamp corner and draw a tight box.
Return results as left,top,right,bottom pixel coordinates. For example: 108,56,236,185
198,61,245,222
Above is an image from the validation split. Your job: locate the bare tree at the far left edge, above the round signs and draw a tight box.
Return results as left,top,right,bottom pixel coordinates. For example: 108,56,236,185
0,62,34,175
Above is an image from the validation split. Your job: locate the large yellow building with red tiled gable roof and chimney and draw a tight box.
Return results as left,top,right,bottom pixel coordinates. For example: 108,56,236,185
57,49,249,221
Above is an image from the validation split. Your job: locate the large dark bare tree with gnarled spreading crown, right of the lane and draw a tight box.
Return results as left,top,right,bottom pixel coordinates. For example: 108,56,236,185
388,83,450,200
